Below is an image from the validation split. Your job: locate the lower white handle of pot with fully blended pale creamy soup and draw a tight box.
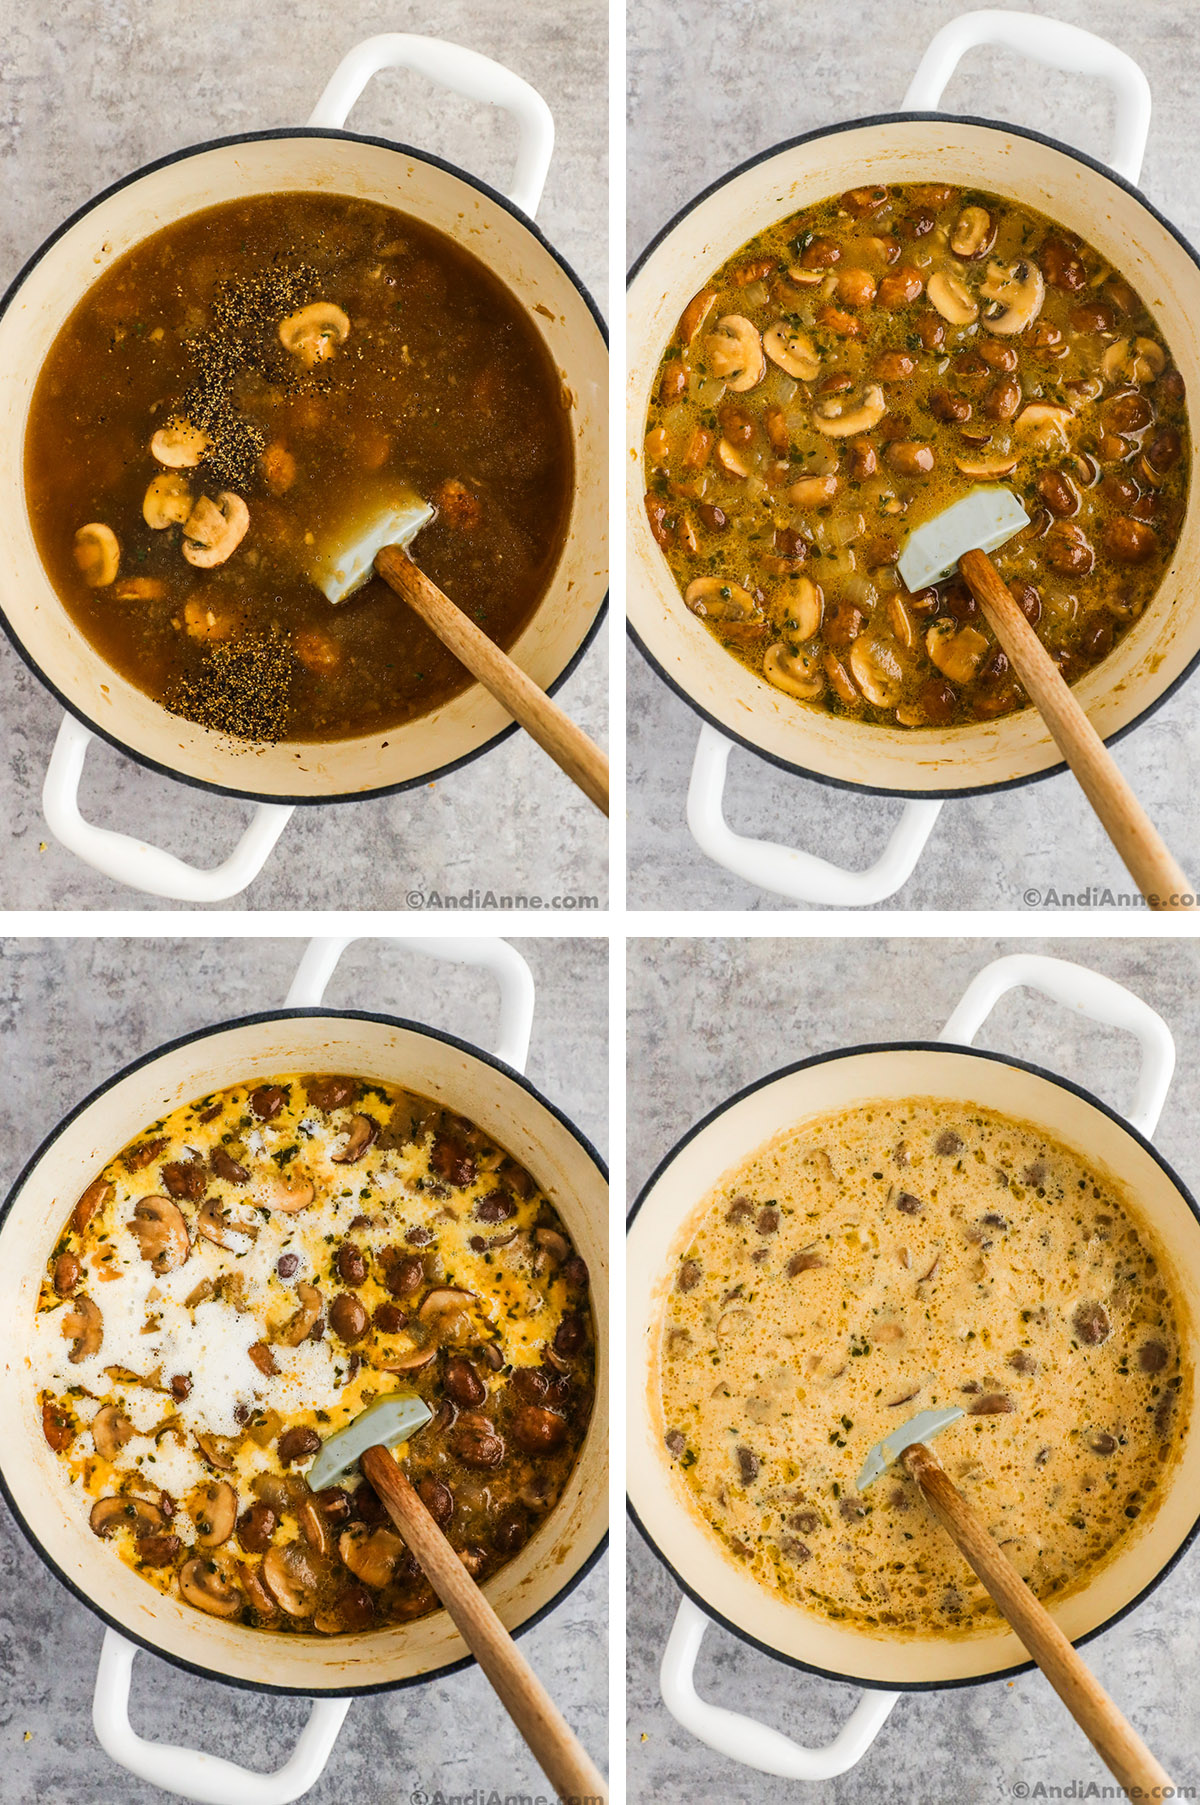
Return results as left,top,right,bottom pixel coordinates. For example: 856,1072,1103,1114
659,1597,900,1780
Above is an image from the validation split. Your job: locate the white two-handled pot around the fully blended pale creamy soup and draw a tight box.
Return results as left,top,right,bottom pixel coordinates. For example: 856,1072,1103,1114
626,953,1200,1780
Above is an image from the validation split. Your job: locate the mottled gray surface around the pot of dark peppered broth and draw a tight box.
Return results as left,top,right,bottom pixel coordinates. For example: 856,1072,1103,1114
0,0,608,910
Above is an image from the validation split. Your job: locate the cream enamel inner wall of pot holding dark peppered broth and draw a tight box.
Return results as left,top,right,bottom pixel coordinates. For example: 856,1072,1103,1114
0,132,608,801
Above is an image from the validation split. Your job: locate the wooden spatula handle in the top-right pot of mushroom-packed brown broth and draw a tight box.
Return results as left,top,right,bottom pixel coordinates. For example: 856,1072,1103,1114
958,552,1195,910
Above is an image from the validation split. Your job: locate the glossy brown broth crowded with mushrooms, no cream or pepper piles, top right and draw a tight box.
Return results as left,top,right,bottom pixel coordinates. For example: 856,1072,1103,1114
646,182,1189,727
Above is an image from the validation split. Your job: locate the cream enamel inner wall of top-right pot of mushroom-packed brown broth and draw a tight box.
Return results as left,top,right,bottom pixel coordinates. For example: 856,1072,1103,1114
626,116,1200,794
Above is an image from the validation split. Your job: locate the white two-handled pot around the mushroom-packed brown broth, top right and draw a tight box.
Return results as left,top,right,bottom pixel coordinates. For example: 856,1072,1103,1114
626,13,1200,906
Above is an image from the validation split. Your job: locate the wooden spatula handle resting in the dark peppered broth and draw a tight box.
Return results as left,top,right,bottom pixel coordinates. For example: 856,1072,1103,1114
375,545,608,814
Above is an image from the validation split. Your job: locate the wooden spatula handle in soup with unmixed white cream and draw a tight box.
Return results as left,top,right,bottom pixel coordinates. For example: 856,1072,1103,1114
361,1448,608,1805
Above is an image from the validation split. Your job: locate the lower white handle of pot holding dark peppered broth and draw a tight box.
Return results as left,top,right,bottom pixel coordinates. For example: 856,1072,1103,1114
42,715,292,903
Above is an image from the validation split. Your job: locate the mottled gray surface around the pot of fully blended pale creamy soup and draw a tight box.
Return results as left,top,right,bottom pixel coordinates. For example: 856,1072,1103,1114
628,939,1200,1805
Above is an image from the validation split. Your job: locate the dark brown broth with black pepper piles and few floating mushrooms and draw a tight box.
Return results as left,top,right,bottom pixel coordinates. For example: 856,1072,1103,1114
25,193,574,742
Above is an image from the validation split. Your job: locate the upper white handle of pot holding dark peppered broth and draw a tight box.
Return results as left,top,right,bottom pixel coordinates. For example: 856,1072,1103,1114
309,31,554,218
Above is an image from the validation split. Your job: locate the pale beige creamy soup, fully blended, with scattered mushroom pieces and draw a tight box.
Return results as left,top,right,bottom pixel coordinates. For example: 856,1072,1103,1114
655,1099,1187,1635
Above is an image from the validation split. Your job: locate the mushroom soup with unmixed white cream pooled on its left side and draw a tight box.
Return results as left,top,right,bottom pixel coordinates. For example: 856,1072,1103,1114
32,1076,594,1635
